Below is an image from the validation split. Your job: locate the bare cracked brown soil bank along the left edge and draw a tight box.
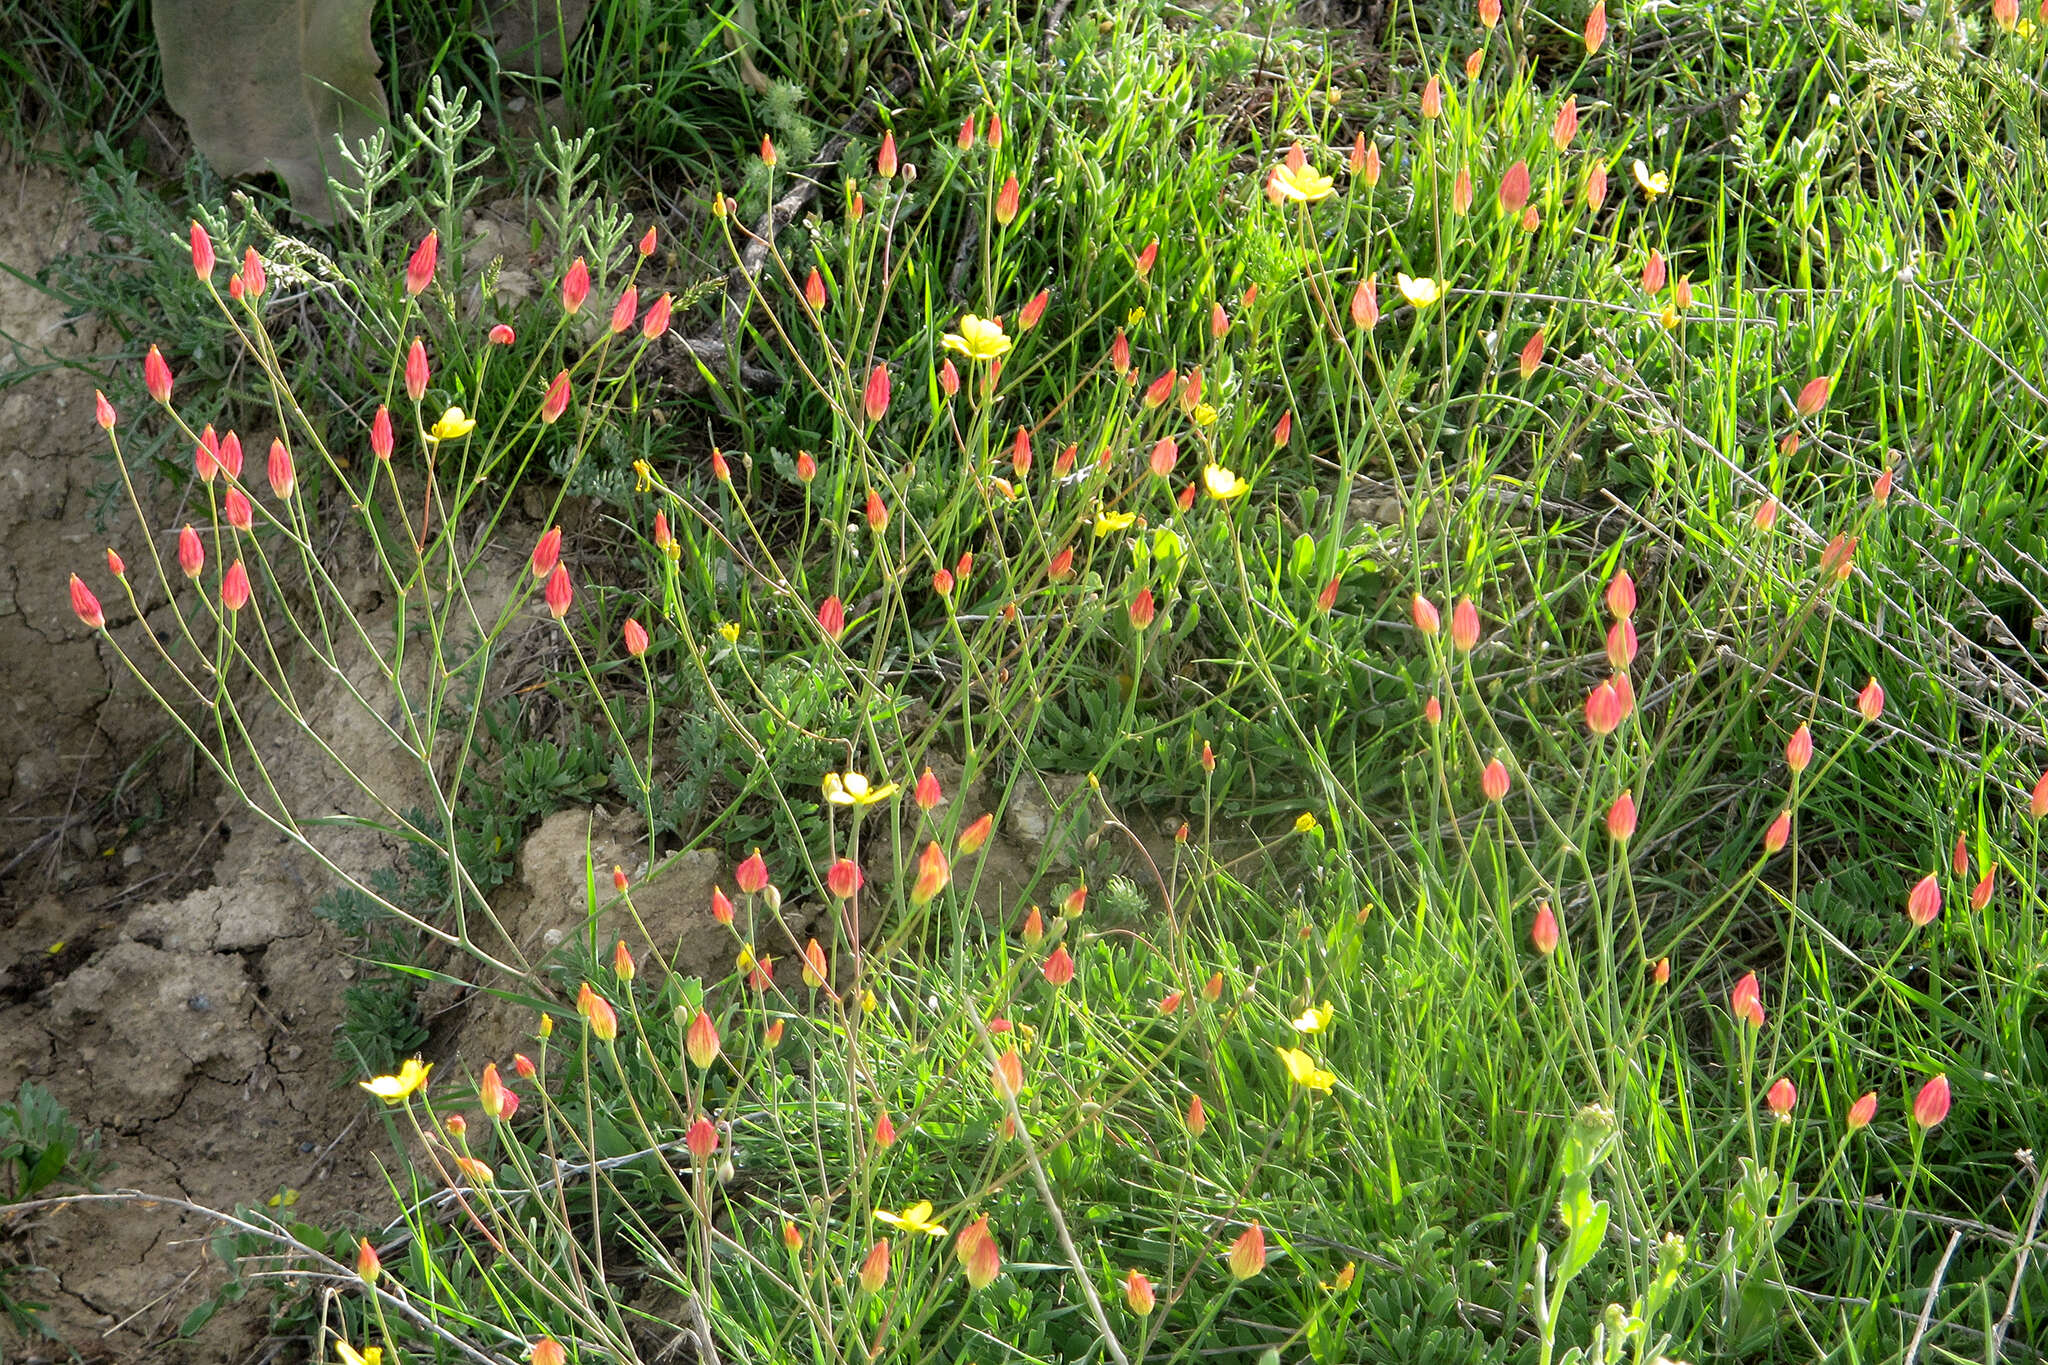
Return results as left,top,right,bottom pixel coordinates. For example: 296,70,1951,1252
0,151,389,1363
